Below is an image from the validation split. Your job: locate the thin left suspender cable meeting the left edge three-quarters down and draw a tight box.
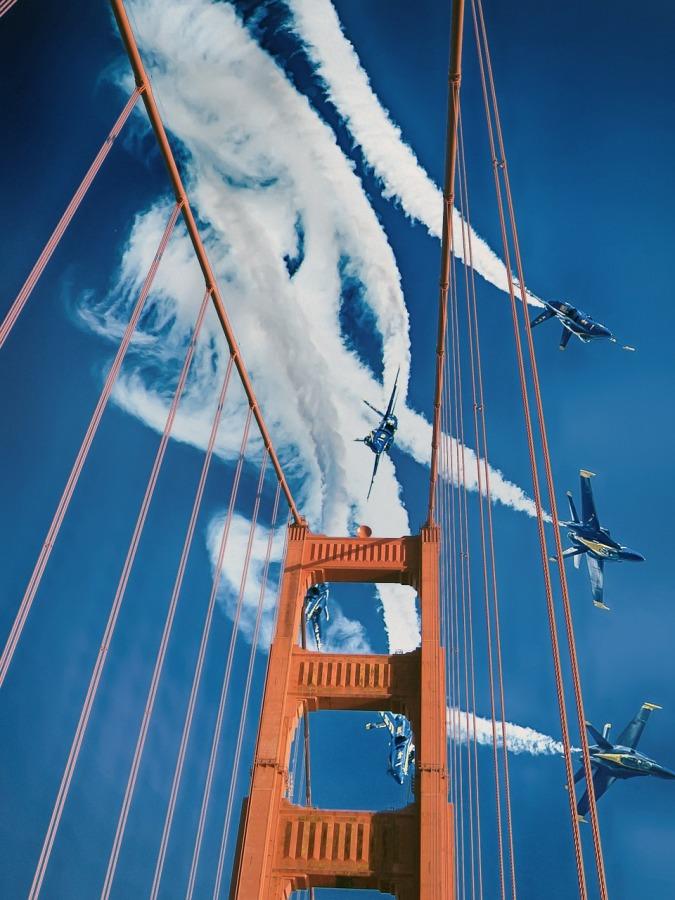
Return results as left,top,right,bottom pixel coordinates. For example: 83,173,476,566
0,204,180,687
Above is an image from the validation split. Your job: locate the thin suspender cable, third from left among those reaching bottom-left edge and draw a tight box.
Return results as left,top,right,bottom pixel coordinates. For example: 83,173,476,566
150,407,253,900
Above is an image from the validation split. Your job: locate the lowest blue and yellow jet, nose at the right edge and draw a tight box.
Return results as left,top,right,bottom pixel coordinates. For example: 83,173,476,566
574,703,675,822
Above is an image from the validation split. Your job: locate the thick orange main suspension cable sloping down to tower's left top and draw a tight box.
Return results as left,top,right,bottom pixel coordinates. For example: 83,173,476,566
110,0,301,522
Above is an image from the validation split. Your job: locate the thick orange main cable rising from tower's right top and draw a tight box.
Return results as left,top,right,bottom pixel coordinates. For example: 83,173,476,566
427,0,464,525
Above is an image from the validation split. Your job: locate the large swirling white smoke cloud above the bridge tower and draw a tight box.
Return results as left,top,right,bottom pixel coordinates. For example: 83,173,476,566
79,0,544,651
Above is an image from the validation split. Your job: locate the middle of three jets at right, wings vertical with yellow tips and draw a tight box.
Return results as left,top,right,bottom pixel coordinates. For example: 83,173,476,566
551,469,644,609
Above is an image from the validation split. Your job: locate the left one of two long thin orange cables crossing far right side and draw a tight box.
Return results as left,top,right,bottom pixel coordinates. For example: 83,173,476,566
471,0,588,898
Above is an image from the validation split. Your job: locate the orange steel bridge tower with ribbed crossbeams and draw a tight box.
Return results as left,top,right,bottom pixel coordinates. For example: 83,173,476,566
230,524,455,900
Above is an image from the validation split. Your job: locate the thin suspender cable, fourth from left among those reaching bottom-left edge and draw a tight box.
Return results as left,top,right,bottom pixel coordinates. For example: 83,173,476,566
185,450,268,900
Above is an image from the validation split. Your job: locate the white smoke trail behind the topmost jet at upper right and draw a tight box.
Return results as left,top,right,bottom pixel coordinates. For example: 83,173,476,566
286,0,543,306
